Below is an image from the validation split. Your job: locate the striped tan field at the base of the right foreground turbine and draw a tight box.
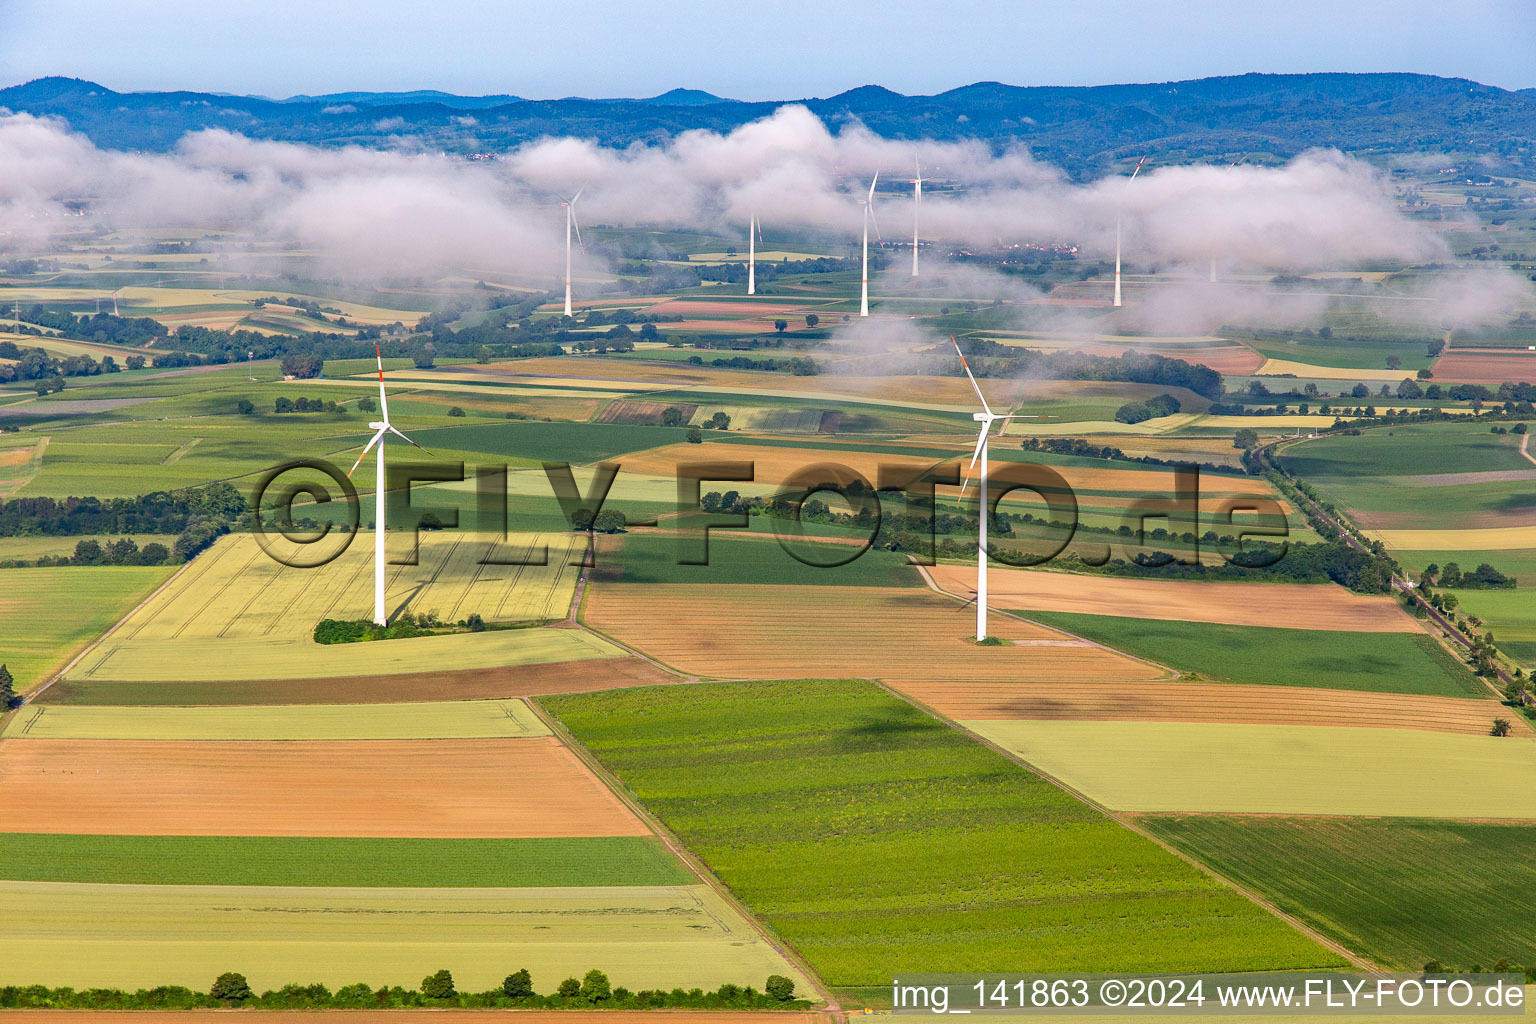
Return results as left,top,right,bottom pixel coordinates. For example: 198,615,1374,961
585,583,1164,682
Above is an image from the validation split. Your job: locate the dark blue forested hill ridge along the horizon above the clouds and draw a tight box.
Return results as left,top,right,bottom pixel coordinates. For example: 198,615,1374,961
0,74,1536,177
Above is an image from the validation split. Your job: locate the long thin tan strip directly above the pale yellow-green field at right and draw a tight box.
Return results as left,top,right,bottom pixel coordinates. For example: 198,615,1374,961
888,680,1499,735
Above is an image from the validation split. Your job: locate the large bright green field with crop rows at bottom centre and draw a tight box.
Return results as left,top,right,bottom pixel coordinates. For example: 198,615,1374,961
544,682,1336,998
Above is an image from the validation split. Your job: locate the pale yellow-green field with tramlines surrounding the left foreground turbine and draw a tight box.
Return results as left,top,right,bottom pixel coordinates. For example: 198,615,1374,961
59,533,622,682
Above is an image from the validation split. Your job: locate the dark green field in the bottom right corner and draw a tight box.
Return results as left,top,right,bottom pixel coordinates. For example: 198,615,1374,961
1141,817,1536,970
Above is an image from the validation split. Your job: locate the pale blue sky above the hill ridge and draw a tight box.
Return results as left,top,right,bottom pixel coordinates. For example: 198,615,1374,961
0,0,1536,100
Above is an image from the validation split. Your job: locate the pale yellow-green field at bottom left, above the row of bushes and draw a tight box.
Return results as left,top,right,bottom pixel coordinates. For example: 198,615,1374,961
0,881,811,994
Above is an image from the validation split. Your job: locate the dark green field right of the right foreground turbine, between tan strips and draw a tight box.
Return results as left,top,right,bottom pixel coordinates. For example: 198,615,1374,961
1023,611,1490,697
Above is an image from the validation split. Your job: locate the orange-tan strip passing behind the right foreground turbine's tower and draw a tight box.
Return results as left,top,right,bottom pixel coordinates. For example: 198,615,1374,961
928,565,1421,633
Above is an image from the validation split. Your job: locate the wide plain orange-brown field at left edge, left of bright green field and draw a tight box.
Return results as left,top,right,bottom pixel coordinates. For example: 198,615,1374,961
0,737,648,838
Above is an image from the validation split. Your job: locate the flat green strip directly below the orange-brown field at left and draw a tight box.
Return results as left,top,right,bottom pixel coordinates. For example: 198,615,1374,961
0,823,693,889
